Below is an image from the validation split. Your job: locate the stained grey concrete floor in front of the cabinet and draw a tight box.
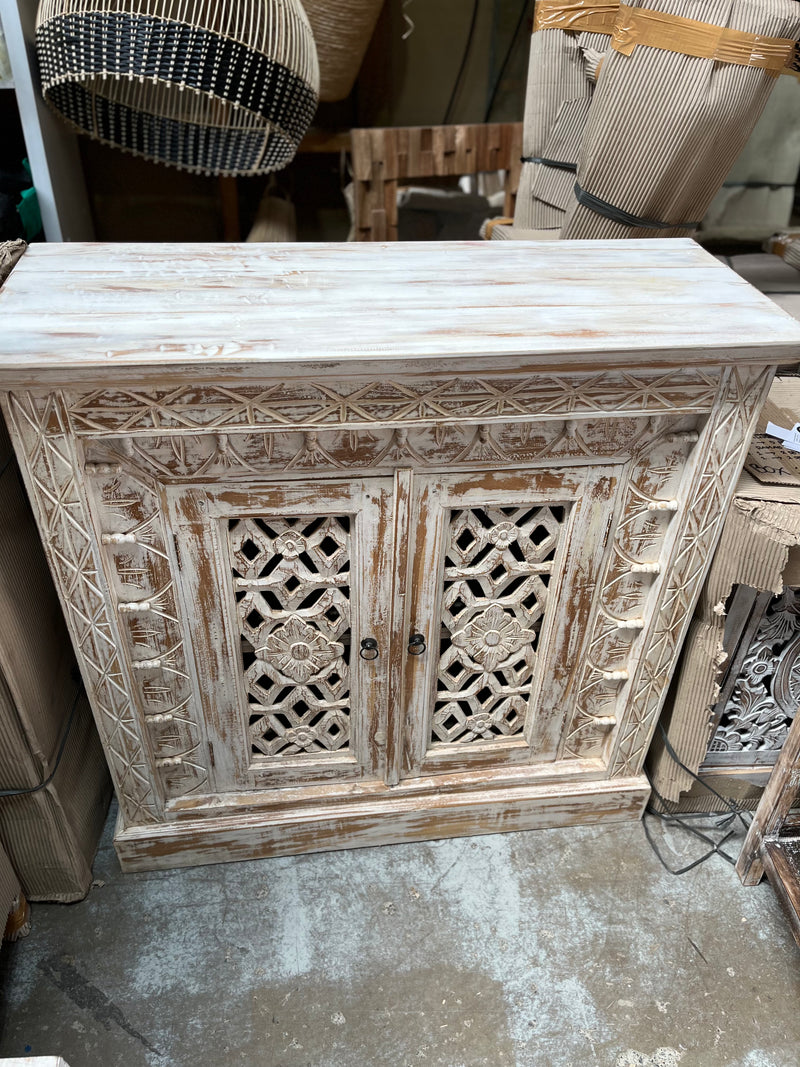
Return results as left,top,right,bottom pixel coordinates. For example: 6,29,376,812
0,802,800,1067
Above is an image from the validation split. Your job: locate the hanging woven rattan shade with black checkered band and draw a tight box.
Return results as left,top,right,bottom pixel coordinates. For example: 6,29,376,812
36,0,319,175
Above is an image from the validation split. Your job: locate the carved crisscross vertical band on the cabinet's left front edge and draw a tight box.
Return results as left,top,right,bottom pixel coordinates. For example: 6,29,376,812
6,394,160,824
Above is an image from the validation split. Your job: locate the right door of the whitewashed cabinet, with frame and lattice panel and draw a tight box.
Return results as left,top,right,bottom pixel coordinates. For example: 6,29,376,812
403,467,618,777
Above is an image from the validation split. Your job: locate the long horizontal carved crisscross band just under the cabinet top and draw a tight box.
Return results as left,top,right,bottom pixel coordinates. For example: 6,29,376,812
69,368,717,436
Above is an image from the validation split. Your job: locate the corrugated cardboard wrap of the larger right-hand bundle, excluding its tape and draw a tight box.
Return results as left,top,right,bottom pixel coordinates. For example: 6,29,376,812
561,0,800,240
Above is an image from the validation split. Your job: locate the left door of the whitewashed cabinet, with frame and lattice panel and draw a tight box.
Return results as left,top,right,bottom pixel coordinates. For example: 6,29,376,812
166,478,391,793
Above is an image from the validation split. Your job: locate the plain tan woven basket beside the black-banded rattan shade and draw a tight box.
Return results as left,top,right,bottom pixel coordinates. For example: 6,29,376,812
303,0,383,101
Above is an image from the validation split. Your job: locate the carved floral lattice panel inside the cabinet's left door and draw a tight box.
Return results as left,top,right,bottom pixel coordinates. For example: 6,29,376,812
228,515,351,762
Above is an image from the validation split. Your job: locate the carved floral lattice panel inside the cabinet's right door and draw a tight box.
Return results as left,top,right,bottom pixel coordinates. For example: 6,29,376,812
430,506,566,747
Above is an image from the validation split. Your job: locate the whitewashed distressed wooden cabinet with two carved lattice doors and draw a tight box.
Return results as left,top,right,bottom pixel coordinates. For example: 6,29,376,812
0,240,800,870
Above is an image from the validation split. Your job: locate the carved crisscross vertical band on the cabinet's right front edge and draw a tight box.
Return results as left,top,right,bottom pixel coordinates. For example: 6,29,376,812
610,368,772,777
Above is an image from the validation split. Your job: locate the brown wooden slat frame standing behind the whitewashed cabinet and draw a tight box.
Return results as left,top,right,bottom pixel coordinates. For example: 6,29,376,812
351,123,523,241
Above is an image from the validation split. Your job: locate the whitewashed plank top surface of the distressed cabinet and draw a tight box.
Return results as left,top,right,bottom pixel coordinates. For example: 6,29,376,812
0,239,800,387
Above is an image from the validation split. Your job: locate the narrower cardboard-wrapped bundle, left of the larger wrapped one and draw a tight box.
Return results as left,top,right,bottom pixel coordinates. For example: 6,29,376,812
514,0,619,237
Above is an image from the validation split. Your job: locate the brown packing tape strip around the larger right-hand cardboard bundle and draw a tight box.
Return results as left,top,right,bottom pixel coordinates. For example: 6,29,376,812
611,4,795,75
